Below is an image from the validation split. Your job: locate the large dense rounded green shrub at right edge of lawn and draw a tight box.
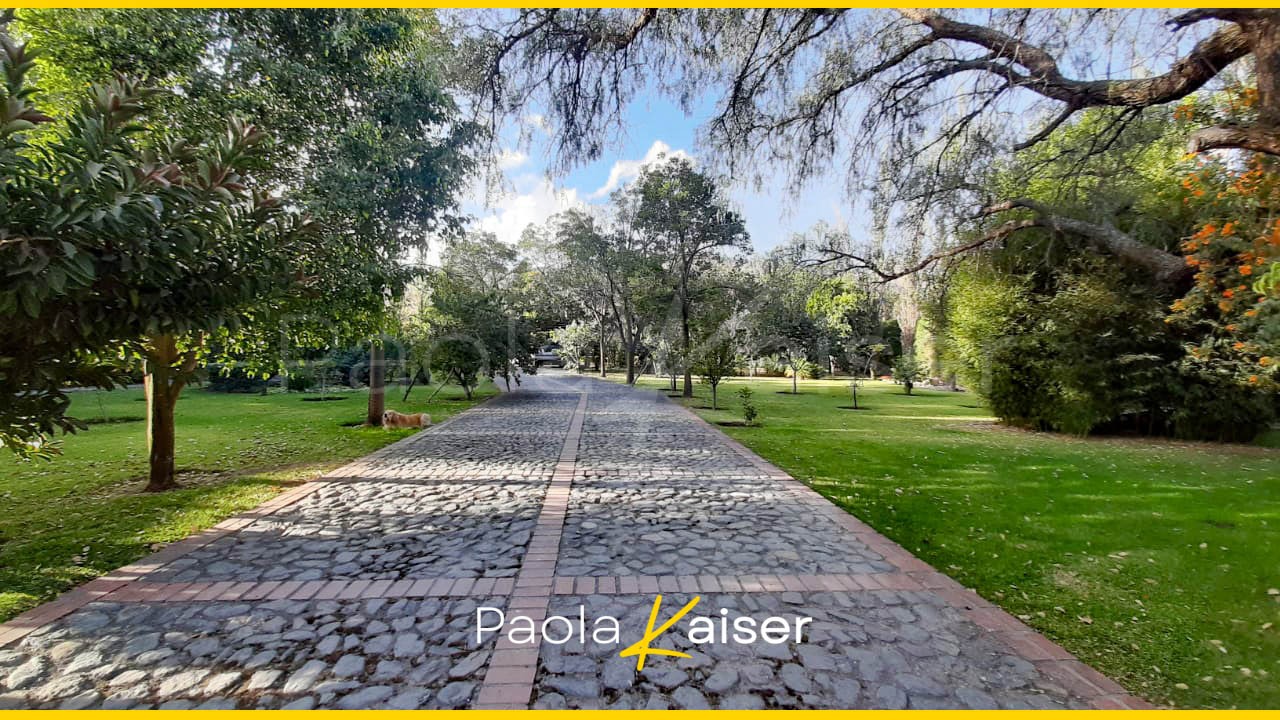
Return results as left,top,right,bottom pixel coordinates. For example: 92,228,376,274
946,257,1276,441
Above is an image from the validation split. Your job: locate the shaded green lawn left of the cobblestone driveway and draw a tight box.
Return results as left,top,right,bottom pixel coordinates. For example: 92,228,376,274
0,384,494,620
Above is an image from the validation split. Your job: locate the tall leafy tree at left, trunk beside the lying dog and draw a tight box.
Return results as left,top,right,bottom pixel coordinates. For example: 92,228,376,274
13,9,475,468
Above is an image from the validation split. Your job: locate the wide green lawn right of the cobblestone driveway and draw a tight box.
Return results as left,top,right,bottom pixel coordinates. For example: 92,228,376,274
624,378,1280,707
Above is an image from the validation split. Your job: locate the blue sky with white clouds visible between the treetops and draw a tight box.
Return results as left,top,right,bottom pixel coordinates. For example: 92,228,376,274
465,89,851,252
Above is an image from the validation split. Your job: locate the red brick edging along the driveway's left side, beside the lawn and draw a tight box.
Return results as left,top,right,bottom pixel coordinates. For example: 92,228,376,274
0,392,503,648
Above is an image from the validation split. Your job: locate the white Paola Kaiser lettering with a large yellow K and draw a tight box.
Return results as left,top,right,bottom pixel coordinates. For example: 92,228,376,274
476,594,813,670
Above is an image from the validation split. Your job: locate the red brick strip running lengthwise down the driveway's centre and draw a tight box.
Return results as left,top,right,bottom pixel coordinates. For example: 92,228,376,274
471,392,588,710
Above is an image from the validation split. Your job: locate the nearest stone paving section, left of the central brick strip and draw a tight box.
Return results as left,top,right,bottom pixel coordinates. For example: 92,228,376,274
0,598,506,710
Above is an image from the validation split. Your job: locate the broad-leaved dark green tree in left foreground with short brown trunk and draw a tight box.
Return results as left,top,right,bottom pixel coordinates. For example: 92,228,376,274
0,32,310,479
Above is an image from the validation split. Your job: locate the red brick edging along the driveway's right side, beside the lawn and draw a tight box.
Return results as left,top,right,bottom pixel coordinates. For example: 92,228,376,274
668,392,1155,710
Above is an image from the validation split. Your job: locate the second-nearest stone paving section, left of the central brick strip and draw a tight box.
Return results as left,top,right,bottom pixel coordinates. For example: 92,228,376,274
148,480,547,583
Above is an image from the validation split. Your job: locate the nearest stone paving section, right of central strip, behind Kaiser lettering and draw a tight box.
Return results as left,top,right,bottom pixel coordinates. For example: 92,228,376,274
532,591,1084,710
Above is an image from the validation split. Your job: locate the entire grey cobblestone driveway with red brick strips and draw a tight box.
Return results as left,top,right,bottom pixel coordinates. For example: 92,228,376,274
0,375,1143,708
